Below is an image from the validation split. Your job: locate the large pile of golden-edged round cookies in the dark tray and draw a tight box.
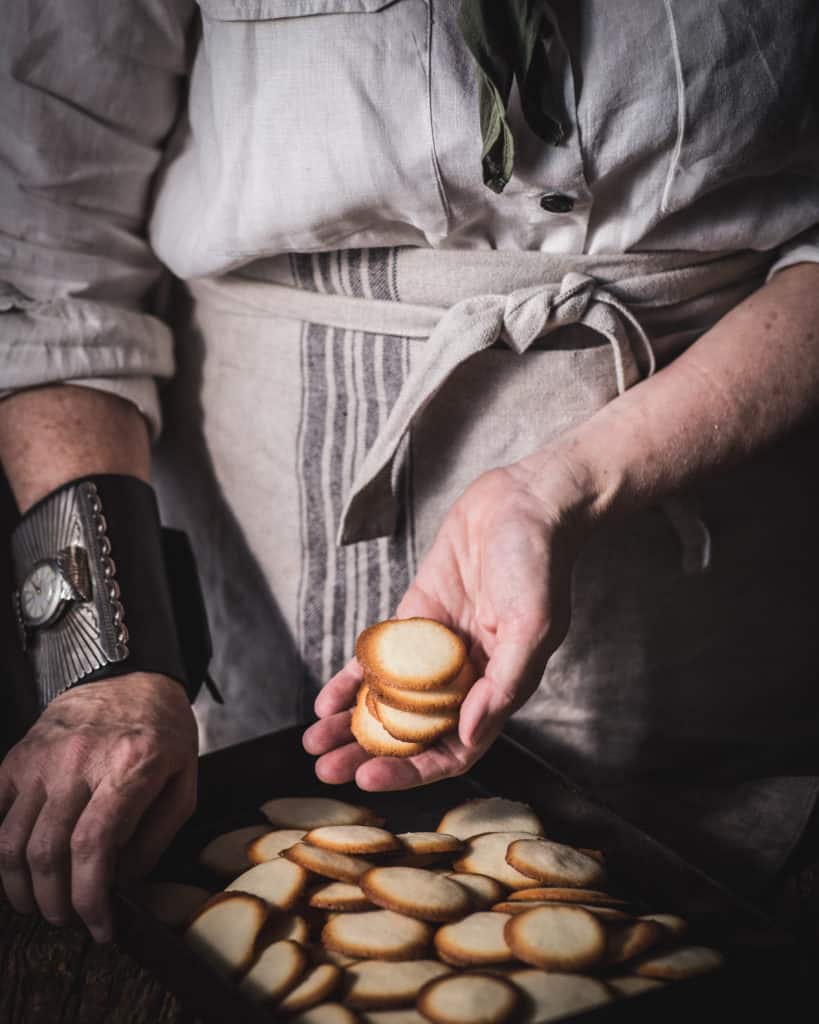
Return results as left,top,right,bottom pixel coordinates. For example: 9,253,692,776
137,798,723,1024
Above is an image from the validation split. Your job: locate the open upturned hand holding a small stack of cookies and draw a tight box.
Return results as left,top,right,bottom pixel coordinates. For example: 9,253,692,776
304,457,593,790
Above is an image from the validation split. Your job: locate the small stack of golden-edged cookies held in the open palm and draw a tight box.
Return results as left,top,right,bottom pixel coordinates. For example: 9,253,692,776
351,618,475,758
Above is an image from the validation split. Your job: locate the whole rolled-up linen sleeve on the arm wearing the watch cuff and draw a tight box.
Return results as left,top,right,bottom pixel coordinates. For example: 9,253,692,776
0,0,195,434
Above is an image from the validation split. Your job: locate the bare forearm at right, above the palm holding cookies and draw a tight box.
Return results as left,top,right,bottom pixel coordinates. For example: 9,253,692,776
521,263,819,522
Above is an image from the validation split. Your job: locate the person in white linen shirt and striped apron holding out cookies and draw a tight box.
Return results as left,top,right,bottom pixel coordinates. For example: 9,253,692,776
0,0,819,941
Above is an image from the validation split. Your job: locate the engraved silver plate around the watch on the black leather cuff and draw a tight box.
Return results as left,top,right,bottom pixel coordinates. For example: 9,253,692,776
11,480,128,708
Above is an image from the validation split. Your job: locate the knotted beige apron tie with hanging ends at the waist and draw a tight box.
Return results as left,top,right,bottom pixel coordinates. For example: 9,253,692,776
338,271,710,572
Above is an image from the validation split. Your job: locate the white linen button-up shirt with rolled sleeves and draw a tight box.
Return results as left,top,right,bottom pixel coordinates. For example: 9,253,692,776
0,0,819,432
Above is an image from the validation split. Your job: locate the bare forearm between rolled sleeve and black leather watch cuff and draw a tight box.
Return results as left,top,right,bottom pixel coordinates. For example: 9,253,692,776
0,385,150,512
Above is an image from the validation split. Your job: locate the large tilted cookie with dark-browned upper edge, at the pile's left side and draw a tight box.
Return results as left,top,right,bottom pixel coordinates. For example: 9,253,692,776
184,893,267,976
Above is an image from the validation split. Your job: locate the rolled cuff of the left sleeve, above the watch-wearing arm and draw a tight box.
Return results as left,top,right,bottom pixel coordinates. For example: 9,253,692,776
0,287,174,438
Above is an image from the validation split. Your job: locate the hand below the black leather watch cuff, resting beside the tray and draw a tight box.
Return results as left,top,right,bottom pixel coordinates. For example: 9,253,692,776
0,673,197,942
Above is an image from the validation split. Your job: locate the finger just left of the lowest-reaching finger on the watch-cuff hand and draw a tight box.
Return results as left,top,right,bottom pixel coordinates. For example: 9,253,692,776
27,782,91,925
